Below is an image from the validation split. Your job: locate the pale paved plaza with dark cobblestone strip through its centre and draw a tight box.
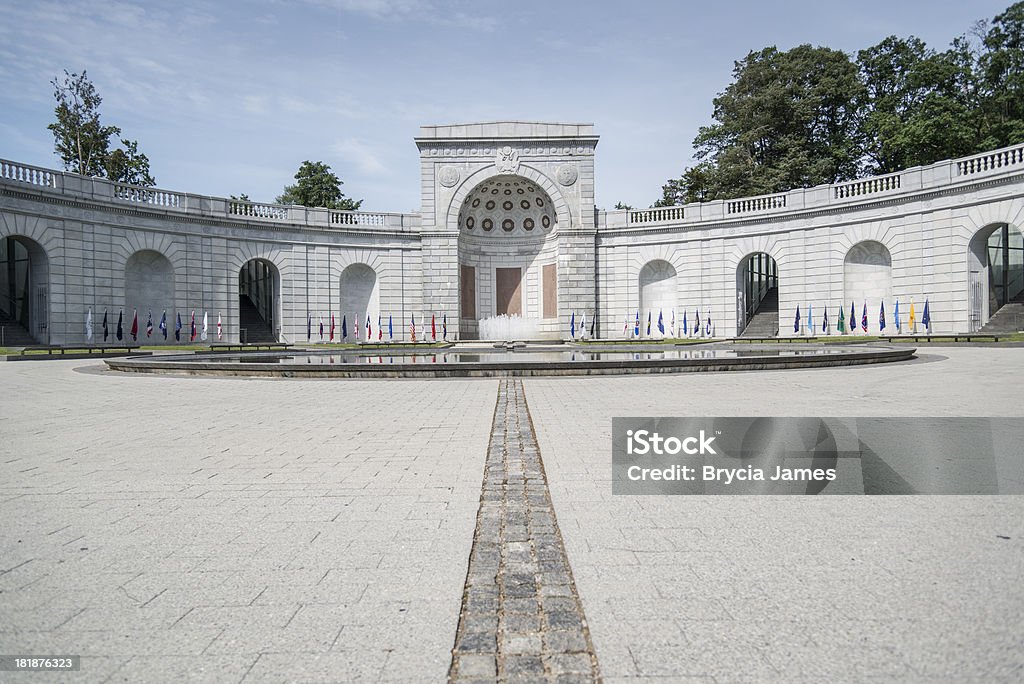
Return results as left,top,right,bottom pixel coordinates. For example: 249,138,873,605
0,346,1024,682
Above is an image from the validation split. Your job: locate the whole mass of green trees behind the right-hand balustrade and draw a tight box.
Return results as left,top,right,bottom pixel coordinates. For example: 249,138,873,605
655,2,1024,207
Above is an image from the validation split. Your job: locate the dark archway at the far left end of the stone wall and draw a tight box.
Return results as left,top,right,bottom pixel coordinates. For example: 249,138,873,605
0,236,49,346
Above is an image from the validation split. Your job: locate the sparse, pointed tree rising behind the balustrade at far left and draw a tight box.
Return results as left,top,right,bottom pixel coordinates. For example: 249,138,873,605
47,70,156,185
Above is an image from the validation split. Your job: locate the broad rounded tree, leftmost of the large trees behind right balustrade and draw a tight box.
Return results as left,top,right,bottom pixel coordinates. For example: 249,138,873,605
683,45,862,199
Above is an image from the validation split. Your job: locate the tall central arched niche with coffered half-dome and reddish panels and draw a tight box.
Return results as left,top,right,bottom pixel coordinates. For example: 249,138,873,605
459,174,561,339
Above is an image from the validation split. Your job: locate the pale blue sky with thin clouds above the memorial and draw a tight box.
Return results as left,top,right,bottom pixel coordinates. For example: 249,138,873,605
0,0,1010,211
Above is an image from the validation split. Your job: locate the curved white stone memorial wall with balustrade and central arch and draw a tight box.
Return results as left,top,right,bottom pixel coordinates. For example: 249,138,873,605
0,122,1024,344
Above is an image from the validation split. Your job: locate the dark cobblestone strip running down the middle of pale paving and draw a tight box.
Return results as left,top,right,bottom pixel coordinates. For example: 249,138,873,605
449,378,600,684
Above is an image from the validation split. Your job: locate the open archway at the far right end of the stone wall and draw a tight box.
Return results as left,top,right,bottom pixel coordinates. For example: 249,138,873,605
968,223,1024,332
